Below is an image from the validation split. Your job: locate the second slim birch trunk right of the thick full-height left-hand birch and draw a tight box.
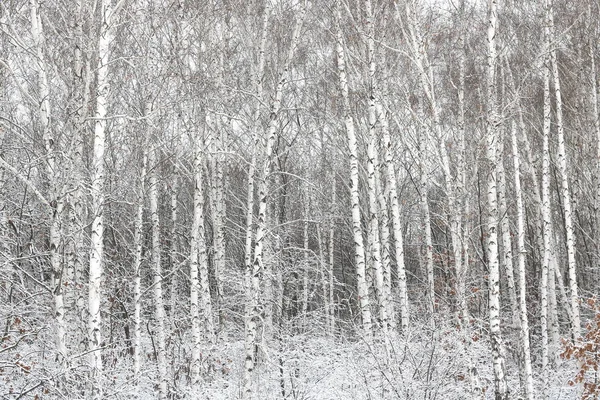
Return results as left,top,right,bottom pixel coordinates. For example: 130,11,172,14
148,147,168,400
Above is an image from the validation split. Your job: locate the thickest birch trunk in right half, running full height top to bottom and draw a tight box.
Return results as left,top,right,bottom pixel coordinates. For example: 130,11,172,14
486,0,508,400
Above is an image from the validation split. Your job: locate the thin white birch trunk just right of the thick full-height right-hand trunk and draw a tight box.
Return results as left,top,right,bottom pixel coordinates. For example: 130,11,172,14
510,120,535,400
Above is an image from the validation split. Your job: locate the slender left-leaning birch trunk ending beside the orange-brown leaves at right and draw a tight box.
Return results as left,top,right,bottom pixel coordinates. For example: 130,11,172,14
546,0,581,340
